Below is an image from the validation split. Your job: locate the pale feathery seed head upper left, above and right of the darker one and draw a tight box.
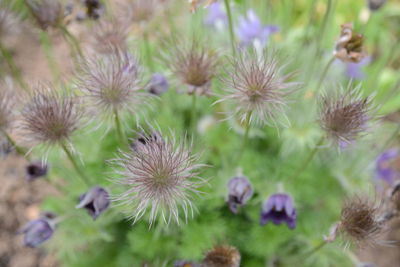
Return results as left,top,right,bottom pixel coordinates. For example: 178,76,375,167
77,48,152,122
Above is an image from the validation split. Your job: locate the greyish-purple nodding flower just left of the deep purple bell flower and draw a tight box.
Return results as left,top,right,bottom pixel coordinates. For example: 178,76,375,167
228,176,253,214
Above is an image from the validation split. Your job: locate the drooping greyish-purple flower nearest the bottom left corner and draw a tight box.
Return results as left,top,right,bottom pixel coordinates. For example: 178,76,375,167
19,218,54,248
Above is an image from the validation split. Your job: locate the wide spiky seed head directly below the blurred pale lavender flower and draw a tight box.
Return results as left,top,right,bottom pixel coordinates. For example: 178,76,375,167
217,53,298,125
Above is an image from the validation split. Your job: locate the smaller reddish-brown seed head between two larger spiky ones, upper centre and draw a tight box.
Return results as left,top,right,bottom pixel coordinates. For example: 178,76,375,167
168,40,218,95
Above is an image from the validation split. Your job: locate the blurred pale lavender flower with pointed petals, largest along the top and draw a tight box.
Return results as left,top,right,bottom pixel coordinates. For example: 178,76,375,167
236,9,279,47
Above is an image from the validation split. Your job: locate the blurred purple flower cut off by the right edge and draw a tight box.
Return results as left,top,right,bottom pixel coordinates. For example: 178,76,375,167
375,149,400,184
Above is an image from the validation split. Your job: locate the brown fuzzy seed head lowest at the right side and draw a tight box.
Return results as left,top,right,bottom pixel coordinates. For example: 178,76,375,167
338,196,383,245
